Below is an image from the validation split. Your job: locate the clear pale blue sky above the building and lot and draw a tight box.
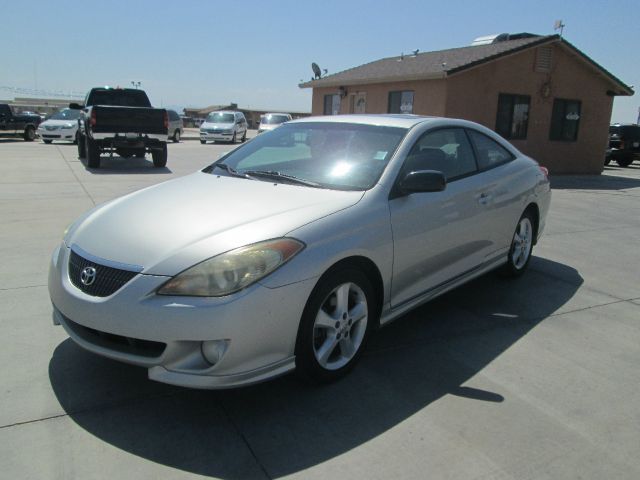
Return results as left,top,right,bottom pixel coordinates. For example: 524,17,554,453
0,0,640,122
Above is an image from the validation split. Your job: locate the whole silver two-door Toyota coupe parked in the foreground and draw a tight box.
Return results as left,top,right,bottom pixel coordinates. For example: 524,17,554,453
49,115,550,388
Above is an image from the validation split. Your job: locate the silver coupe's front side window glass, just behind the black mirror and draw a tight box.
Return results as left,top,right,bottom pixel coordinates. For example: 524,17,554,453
402,128,477,182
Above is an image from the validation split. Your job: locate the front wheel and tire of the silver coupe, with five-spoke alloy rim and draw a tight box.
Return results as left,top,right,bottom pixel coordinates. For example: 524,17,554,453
295,268,376,383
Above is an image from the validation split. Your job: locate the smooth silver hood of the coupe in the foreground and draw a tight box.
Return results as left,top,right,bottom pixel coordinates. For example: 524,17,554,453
65,172,363,275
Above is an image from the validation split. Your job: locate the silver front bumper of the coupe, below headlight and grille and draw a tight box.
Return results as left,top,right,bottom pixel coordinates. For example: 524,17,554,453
49,245,315,389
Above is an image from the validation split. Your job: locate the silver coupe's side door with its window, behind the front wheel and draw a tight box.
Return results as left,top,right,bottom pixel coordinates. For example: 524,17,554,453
389,128,491,308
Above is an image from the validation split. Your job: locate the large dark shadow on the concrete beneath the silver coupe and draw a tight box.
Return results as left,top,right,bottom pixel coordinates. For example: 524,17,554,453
49,257,583,478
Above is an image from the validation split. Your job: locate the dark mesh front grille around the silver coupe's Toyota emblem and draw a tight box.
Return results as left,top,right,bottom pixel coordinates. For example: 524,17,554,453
69,250,137,297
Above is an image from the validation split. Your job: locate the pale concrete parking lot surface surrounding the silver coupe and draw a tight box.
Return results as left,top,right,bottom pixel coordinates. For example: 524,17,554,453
0,140,640,480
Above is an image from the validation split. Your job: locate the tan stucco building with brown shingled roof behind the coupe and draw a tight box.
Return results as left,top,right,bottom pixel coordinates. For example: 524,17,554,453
300,34,634,173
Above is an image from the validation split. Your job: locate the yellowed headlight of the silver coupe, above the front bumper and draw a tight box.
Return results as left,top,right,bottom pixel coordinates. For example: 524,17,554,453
157,238,304,297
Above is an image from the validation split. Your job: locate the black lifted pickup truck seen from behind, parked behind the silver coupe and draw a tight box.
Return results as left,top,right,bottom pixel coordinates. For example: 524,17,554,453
69,87,169,168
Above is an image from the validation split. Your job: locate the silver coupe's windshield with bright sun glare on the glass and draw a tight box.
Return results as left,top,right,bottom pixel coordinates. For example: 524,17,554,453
204,122,407,190
